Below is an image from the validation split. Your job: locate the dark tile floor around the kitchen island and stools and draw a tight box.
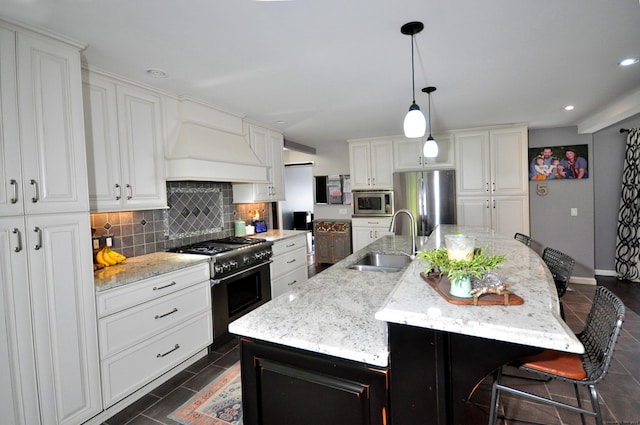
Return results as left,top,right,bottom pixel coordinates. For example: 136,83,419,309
105,266,640,425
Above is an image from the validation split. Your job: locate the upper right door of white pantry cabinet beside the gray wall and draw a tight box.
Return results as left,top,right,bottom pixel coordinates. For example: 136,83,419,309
490,128,529,195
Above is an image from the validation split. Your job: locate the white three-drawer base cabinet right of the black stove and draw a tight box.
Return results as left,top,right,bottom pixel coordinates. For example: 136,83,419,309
270,234,308,299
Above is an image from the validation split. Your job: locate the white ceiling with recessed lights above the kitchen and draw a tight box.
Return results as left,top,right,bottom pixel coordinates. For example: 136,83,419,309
0,0,640,147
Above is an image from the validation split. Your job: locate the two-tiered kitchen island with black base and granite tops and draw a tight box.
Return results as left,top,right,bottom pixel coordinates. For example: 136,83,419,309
229,227,583,424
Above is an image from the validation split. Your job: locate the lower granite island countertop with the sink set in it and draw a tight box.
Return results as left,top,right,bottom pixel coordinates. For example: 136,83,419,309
229,236,411,367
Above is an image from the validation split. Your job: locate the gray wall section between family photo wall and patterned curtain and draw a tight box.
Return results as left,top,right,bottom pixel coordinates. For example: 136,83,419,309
593,115,640,276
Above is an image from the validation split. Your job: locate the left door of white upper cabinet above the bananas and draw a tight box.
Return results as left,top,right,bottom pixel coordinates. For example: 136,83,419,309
83,72,124,211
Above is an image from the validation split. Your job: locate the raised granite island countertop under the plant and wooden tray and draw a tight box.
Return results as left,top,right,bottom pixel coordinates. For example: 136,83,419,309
375,225,584,353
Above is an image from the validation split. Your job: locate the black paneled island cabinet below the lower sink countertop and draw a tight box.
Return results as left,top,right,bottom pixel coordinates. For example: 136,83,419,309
240,338,388,425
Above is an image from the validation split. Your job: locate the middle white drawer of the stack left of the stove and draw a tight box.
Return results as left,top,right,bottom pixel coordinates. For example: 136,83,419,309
99,280,211,359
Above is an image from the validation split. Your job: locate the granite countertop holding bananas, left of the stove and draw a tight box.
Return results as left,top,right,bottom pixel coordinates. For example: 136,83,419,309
93,252,211,292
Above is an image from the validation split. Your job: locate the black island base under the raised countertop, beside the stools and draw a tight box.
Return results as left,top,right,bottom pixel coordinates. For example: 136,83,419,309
388,323,540,425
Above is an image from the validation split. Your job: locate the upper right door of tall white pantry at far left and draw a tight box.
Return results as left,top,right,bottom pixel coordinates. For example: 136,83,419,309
17,32,89,213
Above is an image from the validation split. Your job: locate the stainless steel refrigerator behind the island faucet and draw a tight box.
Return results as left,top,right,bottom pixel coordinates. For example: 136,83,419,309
393,170,456,236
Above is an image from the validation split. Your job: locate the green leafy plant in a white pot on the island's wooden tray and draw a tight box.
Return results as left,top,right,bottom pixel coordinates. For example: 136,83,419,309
416,243,506,298
